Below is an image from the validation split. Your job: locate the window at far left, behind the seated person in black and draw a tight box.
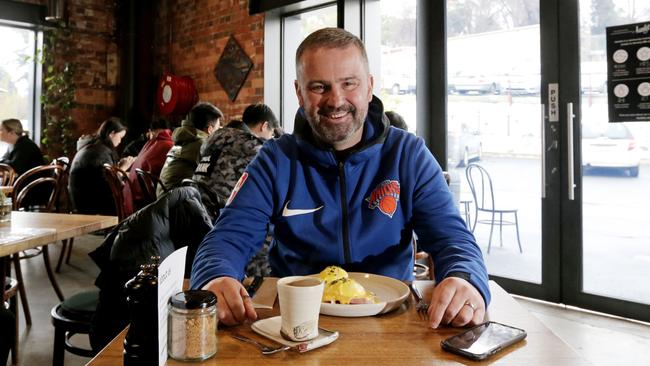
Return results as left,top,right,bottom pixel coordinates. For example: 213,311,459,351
0,25,40,156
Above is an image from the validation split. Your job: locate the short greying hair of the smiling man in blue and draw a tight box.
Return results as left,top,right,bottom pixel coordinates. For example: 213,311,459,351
296,28,370,76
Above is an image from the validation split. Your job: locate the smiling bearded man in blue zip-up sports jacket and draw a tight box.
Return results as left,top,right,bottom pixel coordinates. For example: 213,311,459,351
191,28,490,328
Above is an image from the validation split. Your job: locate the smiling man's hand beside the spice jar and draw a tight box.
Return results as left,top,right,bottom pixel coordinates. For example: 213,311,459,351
203,277,257,325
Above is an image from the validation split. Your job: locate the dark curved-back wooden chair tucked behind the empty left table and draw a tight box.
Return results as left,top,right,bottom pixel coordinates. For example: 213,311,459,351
11,165,64,325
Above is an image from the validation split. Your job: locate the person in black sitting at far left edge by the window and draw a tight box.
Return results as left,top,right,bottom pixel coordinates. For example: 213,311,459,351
0,118,43,175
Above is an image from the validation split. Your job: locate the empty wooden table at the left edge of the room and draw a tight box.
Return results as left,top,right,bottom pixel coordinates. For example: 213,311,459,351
0,211,117,298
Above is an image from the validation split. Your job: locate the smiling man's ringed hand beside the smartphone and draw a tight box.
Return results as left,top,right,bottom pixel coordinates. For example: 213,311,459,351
429,277,485,328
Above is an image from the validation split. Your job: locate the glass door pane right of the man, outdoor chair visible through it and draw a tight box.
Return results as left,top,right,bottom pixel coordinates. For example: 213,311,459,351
447,0,542,285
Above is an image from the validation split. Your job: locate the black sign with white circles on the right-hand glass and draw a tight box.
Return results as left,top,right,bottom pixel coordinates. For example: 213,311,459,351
606,22,650,122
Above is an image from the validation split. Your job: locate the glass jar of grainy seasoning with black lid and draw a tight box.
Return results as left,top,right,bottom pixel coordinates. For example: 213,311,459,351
167,290,217,361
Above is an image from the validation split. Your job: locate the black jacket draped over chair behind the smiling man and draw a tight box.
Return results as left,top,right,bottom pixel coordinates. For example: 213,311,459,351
89,187,212,350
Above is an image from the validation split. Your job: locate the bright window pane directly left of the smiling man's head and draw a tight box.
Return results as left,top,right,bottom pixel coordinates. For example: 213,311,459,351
281,4,336,132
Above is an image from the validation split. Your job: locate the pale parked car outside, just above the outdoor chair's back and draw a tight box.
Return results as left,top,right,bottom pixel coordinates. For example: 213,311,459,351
447,122,483,167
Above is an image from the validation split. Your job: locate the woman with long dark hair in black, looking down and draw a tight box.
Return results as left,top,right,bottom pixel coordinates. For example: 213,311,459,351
68,117,134,215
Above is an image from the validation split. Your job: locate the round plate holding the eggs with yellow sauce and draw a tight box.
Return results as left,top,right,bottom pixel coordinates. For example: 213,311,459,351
320,272,409,317
